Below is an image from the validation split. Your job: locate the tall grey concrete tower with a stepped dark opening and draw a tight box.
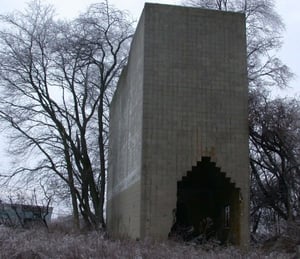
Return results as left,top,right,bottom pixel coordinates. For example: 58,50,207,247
107,3,249,246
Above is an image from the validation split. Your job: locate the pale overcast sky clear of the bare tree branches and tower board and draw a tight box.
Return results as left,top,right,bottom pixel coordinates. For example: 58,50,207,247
0,0,300,171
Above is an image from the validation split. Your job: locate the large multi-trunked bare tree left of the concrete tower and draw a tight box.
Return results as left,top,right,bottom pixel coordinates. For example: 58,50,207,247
0,1,132,231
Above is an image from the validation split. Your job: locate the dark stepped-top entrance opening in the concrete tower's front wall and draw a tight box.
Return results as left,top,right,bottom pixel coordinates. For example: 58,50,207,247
170,157,240,244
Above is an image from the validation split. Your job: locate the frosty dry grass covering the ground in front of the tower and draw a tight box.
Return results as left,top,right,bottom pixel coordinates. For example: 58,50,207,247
0,226,295,259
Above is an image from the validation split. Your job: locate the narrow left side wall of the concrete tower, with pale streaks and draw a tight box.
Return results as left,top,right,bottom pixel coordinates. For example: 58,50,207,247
107,12,144,238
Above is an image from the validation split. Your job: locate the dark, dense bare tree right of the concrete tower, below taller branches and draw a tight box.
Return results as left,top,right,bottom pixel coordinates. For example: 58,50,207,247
249,92,300,239
